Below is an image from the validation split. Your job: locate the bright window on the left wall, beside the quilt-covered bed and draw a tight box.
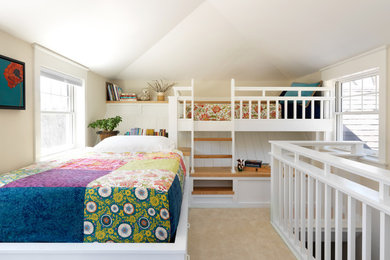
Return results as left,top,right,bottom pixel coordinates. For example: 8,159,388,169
40,69,82,156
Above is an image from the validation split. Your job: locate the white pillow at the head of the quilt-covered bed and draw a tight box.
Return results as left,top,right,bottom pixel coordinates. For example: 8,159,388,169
94,135,175,153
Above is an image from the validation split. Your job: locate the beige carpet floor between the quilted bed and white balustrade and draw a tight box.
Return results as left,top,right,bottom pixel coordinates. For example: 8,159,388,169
188,208,295,260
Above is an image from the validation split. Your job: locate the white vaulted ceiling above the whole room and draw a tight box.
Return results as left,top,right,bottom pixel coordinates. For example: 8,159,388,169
0,0,390,81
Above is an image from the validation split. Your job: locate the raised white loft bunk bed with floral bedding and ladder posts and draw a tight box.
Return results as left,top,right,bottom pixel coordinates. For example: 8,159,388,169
169,79,335,172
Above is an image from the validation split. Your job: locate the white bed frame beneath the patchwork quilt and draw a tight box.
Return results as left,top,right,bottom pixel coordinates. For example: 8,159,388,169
0,179,189,260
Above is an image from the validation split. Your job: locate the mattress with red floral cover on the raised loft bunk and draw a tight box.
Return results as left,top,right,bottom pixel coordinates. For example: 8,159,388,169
186,102,281,121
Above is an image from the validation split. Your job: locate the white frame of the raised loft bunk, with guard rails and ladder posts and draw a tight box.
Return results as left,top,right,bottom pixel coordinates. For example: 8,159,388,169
168,79,335,172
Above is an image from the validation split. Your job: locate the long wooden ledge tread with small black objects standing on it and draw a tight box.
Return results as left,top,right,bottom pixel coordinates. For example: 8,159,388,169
191,167,271,177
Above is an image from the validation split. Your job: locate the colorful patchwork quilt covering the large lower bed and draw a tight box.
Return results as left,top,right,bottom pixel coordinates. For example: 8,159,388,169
0,152,185,243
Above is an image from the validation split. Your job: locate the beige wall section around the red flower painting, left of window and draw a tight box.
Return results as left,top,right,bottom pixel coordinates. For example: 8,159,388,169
0,31,34,173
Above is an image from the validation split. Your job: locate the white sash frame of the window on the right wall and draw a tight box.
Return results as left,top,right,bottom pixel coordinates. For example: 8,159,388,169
335,68,383,157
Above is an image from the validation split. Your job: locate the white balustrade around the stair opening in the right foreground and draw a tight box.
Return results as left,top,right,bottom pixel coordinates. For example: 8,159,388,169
271,141,390,260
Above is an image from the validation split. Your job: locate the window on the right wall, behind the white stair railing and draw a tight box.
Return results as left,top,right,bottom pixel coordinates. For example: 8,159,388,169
336,70,379,156
